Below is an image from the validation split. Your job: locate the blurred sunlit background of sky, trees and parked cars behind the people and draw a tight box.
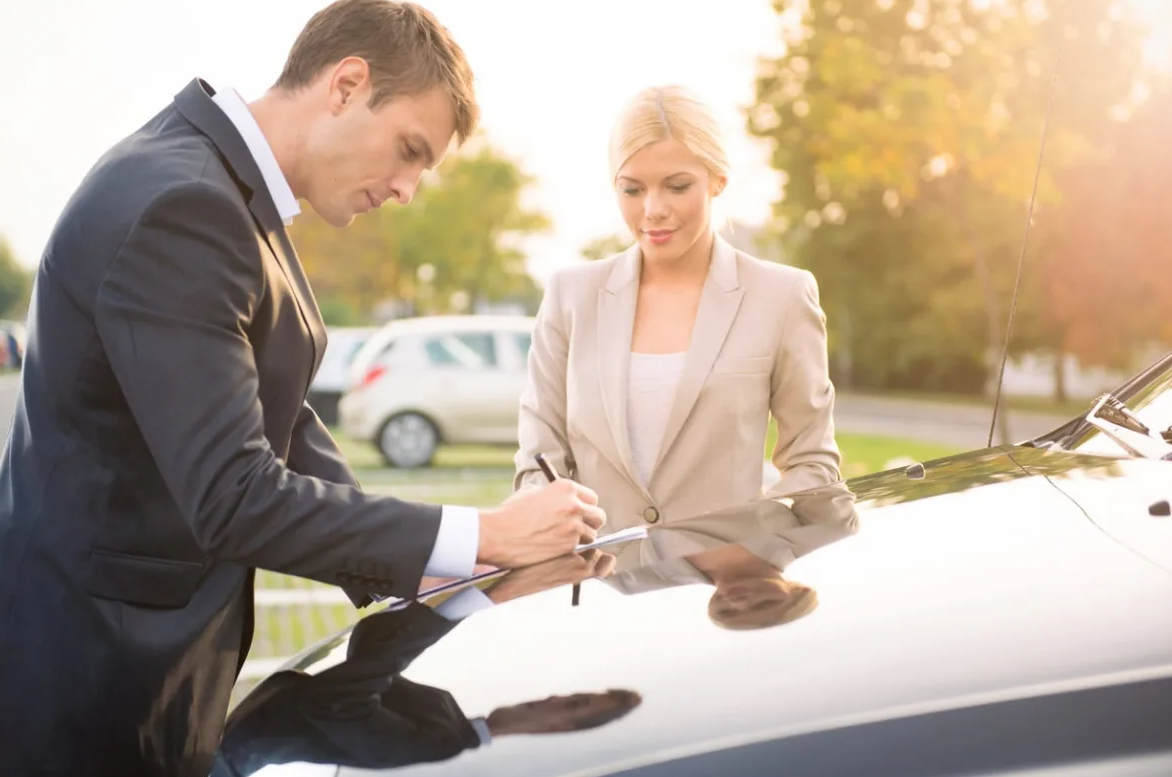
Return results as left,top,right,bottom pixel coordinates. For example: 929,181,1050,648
0,0,1172,693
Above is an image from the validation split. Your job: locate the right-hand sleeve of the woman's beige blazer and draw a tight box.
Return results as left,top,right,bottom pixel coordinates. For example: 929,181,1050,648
769,271,841,493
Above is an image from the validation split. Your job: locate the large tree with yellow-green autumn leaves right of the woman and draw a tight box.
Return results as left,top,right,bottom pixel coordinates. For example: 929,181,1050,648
747,0,1138,431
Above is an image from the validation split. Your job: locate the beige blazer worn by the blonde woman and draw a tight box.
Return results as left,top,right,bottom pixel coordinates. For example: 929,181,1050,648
513,237,840,532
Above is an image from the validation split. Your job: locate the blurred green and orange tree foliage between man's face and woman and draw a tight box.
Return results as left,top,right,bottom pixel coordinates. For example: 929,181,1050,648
291,138,550,319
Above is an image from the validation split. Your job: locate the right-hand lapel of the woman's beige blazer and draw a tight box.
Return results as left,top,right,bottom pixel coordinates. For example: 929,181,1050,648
652,236,744,479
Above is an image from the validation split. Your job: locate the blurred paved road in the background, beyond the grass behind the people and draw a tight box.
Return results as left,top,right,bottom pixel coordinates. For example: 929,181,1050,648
0,375,1069,449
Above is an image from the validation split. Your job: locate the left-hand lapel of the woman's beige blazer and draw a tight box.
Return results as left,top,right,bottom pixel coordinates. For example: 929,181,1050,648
595,245,650,500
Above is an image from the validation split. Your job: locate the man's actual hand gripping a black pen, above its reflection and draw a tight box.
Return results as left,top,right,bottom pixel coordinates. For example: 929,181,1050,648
476,478,606,568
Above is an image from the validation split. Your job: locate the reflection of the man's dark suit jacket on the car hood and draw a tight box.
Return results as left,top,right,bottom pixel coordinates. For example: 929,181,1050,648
212,604,481,777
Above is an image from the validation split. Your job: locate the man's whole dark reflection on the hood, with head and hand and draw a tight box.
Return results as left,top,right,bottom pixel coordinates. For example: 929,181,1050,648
211,551,642,777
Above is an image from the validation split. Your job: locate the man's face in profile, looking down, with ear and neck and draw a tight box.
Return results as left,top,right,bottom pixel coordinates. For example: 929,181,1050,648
301,60,456,227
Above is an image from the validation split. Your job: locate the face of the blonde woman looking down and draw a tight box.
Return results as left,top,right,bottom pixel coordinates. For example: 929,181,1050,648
614,138,724,270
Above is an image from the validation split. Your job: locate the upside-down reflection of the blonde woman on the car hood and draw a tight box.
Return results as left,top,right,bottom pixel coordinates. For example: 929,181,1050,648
604,484,858,629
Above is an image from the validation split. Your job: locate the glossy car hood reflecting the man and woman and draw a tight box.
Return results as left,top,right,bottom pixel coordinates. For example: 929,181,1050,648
217,449,1172,776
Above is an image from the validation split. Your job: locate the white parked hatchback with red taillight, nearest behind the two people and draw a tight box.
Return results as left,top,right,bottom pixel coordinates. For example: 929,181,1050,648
338,315,533,468
